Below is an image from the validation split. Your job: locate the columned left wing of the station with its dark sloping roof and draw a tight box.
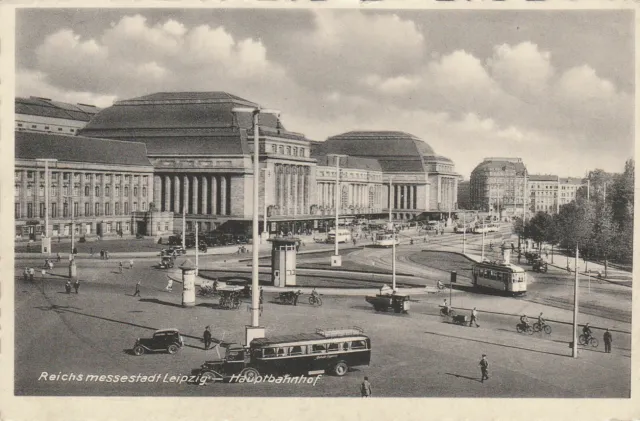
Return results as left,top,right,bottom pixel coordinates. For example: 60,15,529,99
14,131,173,239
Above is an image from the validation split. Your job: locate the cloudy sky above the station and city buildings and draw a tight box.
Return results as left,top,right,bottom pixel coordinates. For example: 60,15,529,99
16,8,635,179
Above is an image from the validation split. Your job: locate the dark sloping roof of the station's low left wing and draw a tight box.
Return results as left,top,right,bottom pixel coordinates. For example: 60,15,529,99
15,131,151,167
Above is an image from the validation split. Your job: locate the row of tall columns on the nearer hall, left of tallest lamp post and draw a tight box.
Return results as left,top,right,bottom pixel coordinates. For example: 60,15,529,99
154,174,231,216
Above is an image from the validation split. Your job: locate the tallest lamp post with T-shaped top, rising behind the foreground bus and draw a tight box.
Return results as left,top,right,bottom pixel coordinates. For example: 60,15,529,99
231,107,280,345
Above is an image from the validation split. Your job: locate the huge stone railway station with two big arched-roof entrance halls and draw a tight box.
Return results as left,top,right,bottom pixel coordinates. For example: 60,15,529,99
16,92,460,236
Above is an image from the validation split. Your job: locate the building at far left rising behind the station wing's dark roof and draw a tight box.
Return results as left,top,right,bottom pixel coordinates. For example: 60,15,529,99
15,96,100,135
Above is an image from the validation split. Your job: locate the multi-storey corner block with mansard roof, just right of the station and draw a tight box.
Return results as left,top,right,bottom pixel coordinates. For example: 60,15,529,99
469,158,528,214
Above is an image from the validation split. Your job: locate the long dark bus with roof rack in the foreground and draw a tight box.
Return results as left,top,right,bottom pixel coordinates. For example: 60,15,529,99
198,327,371,383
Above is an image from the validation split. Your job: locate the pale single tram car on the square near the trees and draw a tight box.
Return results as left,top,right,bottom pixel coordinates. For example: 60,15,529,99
472,261,527,296
